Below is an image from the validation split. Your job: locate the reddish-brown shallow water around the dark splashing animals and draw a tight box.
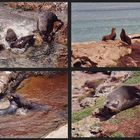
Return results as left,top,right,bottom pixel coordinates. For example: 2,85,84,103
0,74,67,138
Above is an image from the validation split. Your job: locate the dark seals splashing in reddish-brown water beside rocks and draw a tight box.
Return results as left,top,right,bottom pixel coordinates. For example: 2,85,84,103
0,94,51,115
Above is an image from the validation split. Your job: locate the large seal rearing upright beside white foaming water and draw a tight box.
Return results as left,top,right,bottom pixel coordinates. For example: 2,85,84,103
37,11,63,42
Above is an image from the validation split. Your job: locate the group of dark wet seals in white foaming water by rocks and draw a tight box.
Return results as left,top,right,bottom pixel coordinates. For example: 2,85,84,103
5,11,64,48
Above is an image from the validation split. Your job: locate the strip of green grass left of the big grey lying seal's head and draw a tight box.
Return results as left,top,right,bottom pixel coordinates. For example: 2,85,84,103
72,97,105,123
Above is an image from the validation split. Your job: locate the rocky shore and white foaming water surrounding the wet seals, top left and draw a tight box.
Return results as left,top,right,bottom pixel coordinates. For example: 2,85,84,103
0,3,67,68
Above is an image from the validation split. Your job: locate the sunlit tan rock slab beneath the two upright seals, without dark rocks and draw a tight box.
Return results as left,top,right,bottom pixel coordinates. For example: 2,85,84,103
72,40,131,67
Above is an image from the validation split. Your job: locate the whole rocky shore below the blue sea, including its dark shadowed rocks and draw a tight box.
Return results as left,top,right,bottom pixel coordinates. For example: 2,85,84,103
72,34,140,67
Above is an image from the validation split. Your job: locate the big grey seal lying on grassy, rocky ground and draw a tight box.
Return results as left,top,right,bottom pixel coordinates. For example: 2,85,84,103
105,86,140,113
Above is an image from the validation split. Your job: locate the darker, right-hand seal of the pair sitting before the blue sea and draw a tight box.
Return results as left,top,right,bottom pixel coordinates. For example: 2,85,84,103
120,28,131,45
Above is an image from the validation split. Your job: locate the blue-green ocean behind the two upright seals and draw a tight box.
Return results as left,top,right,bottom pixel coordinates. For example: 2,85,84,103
71,3,140,42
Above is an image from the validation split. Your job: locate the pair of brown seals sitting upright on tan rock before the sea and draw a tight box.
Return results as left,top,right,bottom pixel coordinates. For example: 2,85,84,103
102,27,131,45
